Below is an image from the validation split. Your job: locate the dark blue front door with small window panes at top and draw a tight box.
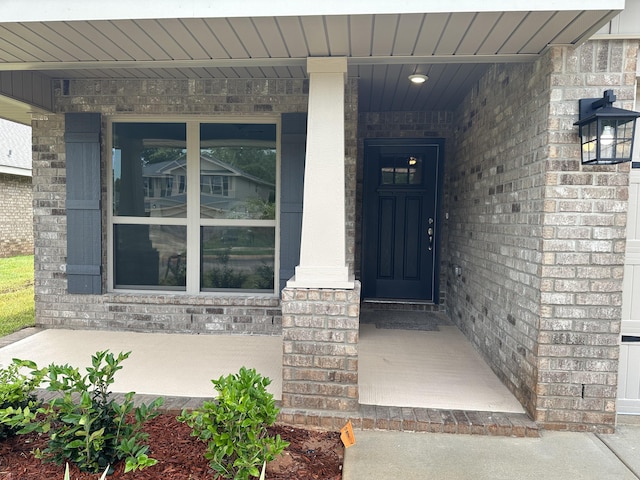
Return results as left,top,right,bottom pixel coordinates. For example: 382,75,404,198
362,139,443,303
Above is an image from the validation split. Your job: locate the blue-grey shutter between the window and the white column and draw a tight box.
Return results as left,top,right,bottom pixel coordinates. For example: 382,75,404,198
280,113,307,289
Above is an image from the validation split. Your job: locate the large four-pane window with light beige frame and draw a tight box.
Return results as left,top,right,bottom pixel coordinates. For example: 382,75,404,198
110,121,277,293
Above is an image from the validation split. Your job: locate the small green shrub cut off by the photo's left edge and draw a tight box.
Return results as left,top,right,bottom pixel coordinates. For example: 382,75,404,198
0,358,47,439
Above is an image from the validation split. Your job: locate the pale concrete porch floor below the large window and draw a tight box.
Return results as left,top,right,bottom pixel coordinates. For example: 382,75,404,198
0,329,282,400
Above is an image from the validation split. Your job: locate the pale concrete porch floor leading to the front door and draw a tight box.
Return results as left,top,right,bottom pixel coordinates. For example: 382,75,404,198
358,323,524,413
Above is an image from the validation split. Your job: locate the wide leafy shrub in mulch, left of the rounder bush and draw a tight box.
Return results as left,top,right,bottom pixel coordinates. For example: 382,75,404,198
0,351,163,472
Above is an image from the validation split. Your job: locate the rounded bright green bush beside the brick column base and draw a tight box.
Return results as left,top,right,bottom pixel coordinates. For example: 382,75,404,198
178,367,289,480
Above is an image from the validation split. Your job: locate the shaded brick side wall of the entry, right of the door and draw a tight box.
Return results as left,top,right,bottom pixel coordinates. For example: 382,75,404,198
445,57,549,411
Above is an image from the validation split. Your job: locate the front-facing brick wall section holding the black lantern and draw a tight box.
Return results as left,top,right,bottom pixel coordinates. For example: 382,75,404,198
536,40,640,431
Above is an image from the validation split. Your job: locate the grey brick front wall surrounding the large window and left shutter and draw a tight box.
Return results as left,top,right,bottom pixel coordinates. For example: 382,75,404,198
33,79,357,334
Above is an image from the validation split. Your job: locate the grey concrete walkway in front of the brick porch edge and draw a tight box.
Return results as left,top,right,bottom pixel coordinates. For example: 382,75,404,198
342,425,640,480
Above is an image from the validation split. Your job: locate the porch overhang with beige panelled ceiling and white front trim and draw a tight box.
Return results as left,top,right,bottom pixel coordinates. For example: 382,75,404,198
0,0,625,123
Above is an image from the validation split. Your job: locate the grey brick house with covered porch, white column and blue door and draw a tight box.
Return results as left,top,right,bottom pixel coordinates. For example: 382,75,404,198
0,0,640,432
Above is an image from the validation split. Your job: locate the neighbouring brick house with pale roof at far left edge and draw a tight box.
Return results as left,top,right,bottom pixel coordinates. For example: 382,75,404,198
0,118,33,257
